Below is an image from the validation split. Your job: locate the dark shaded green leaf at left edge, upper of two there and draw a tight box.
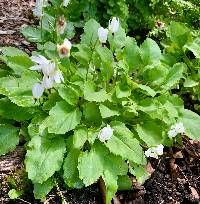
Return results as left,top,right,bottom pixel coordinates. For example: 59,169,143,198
0,98,38,121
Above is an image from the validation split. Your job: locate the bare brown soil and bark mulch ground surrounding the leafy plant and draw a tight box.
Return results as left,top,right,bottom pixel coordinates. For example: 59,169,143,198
0,0,200,204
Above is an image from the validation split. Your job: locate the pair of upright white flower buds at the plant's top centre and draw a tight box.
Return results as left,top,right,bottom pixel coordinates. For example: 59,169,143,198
98,17,119,43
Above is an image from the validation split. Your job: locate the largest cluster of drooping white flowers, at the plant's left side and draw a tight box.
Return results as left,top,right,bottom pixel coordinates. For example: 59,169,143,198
30,55,64,98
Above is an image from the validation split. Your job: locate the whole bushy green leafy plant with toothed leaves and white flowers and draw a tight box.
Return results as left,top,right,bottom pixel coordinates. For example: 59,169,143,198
0,1,200,203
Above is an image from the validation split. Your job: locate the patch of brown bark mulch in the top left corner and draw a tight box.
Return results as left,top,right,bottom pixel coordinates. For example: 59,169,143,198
0,0,35,52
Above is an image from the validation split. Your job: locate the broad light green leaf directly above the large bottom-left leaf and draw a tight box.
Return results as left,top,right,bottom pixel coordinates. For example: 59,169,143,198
43,101,81,134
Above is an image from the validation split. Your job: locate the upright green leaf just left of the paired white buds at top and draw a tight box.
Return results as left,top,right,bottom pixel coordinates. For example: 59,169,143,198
81,19,101,47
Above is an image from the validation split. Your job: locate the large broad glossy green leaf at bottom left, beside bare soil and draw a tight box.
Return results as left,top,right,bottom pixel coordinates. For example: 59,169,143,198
25,136,65,184
